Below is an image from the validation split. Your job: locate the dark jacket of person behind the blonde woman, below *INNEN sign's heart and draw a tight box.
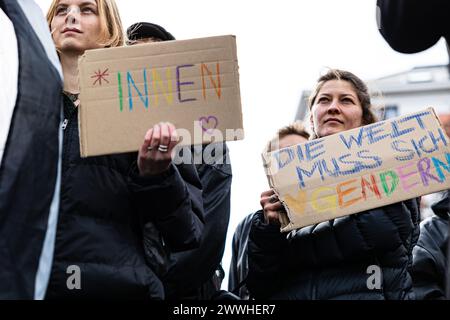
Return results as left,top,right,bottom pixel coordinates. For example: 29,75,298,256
164,143,232,300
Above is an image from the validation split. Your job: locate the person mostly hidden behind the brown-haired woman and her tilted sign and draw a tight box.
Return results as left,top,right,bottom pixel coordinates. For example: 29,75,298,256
228,122,309,300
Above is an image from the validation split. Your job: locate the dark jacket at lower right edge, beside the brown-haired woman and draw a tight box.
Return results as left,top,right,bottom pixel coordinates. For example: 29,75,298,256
411,195,449,300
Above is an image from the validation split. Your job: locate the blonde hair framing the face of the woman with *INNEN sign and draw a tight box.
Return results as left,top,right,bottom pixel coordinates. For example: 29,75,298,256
47,0,125,48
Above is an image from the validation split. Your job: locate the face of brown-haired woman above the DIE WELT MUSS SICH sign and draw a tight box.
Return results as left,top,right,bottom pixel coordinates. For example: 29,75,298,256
311,80,363,137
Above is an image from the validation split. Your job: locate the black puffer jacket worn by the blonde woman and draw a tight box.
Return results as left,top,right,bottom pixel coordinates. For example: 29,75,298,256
47,97,203,299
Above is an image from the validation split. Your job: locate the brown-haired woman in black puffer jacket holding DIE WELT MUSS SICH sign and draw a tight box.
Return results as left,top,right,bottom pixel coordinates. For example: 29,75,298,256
246,69,419,300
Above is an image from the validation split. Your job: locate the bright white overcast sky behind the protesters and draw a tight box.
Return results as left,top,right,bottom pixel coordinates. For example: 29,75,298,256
36,0,448,290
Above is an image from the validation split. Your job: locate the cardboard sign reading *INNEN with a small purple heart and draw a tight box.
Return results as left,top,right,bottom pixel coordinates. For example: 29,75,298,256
79,36,243,157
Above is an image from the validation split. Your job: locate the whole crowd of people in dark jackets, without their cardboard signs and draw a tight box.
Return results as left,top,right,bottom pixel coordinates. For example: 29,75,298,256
0,0,449,300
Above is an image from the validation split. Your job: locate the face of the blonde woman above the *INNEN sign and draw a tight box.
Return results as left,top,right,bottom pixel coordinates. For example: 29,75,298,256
50,0,103,54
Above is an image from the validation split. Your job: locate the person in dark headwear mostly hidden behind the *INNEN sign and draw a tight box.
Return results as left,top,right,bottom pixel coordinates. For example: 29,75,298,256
127,22,235,300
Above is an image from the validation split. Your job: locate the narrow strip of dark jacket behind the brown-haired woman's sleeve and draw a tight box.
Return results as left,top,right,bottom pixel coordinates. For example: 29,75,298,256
228,213,254,299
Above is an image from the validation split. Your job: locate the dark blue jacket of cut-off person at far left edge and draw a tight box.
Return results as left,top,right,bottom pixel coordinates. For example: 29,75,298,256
0,0,62,299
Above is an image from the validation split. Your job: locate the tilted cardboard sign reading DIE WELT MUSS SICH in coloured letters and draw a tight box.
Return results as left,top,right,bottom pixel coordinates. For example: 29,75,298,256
263,108,450,231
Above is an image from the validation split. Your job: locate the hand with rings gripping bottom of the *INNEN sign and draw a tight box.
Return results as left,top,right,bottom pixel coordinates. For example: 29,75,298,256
137,122,179,176
